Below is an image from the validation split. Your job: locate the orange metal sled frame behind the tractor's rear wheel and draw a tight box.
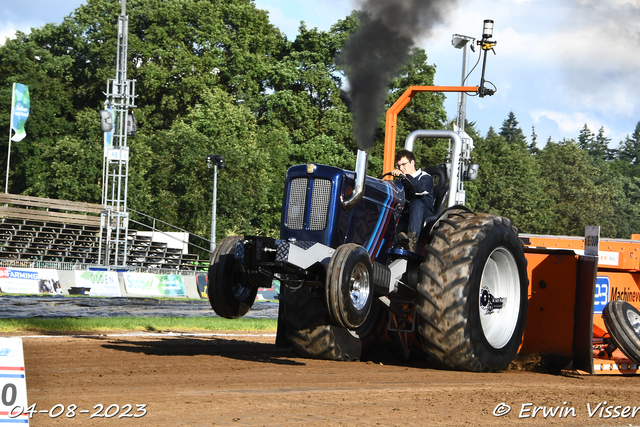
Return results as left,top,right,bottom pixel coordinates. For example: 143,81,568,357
519,234,640,375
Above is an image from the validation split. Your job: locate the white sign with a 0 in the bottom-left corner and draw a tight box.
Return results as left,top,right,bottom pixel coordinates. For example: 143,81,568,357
0,338,29,426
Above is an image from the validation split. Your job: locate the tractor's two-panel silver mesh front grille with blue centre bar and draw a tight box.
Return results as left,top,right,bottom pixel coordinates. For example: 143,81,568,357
286,178,331,231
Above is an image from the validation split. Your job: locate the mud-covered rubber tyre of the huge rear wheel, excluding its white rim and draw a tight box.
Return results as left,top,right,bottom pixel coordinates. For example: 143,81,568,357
416,212,528,371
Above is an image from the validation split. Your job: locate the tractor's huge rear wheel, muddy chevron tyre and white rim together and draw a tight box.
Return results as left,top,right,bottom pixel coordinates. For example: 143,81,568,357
417,210,529,372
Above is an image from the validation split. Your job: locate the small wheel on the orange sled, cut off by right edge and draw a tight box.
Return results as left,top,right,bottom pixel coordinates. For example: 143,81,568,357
602,300,640,364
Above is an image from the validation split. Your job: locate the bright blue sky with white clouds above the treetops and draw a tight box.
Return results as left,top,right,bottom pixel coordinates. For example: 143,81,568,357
0,0,640,148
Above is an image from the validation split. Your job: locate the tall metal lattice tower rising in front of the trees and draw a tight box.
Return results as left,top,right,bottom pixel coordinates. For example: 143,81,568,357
98,0,136,266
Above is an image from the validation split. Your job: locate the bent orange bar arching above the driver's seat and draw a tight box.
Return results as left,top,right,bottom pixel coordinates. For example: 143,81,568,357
382,86,478,179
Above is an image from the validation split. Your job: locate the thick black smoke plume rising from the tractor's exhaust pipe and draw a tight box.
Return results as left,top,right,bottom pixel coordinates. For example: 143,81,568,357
336,0,455,151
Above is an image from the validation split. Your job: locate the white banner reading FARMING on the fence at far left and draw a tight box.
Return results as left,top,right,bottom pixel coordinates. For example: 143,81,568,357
0,267,62,294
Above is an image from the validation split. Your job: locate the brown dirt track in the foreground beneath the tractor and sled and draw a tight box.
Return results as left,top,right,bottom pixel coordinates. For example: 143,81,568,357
8,336,640,426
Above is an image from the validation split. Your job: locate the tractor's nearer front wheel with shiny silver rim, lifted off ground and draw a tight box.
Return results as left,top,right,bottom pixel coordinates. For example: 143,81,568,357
325,243,373,329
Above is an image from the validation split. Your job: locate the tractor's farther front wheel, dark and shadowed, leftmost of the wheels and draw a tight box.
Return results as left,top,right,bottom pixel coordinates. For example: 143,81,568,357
209,236,258,319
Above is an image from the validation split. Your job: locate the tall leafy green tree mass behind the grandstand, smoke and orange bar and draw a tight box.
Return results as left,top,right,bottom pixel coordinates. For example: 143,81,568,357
0,0,447,241
